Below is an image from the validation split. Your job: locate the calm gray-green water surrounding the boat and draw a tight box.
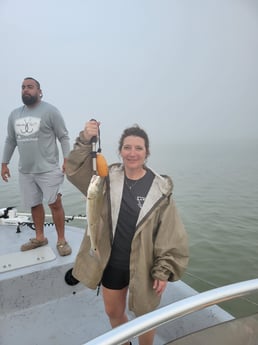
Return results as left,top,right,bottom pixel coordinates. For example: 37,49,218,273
0,141,258,316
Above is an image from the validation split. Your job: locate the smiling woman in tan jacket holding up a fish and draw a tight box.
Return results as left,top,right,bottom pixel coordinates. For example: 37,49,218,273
66,121,188,345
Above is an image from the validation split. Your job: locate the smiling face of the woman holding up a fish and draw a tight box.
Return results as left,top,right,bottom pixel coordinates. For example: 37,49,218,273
120,135,147,170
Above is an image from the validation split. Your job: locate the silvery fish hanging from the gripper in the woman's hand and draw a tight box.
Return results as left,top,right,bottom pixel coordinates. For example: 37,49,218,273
86,175,105,258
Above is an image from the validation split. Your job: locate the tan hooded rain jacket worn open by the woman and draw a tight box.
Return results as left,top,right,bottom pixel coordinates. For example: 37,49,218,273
66,132,189,316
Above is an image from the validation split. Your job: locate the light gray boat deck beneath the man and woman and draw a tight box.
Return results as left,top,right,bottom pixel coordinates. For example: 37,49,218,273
0,225,232,345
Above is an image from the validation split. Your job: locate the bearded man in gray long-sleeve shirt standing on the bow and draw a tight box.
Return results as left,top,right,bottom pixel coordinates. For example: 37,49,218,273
1,77,72,256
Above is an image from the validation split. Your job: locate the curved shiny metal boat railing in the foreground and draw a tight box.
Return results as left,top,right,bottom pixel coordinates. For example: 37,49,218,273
82,279,258,345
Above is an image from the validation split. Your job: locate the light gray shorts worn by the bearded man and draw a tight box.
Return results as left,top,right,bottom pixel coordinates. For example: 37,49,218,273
19,169,64,208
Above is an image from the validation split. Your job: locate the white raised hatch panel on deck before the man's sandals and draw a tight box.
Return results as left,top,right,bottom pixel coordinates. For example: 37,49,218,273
0,246,56,273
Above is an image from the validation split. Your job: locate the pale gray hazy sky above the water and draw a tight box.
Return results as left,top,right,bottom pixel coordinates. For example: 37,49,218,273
0,0,258,162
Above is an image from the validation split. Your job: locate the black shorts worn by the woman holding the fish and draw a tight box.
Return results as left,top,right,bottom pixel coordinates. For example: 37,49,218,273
101,265,130,290
